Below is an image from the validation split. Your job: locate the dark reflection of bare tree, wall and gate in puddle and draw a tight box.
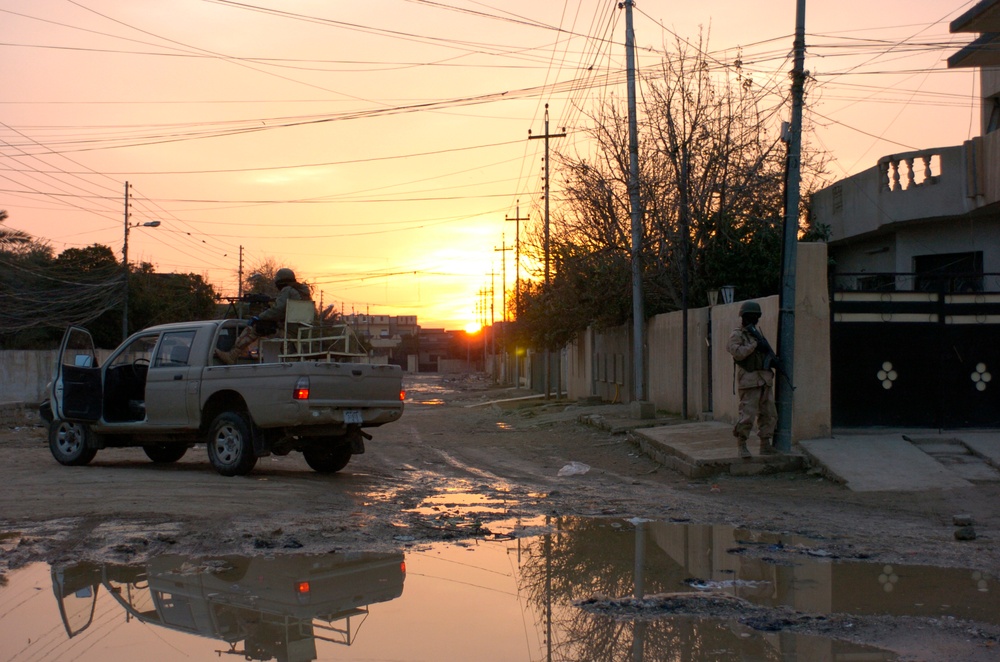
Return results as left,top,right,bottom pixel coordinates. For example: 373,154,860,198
521,519,1000,662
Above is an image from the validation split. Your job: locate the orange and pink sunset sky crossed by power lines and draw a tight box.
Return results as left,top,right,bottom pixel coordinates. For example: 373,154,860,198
0,0,979,329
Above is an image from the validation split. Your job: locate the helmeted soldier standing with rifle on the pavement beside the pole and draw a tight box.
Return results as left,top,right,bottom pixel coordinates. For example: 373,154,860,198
726,301,778,459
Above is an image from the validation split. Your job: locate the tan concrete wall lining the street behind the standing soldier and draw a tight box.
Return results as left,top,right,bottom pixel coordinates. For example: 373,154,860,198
565,243,830,441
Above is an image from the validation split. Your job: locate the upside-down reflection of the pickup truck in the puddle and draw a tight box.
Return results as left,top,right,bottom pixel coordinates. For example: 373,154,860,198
51,552,406,662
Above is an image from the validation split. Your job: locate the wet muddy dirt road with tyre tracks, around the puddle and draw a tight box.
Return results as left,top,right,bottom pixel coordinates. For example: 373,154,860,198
0,376,1000,662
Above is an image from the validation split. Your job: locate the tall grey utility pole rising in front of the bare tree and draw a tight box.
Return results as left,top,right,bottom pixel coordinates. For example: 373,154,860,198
619,0,646,402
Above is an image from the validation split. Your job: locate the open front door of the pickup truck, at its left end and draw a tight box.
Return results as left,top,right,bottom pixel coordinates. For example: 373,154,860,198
52,326,104,423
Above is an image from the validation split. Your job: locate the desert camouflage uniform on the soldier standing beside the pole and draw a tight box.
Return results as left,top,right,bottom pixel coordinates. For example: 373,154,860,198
726,326,778,457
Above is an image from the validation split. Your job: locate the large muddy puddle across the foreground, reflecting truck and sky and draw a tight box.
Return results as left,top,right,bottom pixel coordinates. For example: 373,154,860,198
0,520,1000,662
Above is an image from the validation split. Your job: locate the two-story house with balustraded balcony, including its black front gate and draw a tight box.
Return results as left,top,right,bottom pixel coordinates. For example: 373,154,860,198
811,0,1000,428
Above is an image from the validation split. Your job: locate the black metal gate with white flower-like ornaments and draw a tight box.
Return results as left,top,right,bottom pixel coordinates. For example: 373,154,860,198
830,291,1000,429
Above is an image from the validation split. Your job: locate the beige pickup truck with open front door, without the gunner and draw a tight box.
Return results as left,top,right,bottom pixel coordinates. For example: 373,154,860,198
41,319,404,476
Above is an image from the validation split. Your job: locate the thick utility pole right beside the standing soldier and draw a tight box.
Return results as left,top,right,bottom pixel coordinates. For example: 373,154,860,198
775,0,806,453
